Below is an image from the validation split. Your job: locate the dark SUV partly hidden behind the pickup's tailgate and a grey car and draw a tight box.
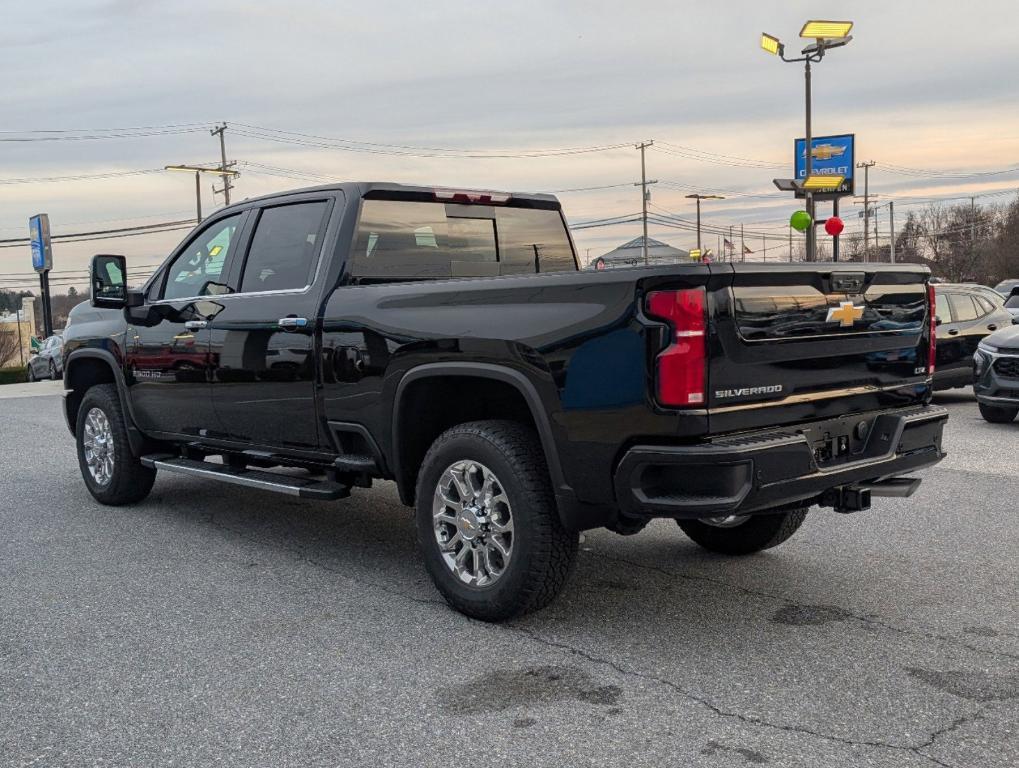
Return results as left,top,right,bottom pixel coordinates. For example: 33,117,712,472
934,283,1012,389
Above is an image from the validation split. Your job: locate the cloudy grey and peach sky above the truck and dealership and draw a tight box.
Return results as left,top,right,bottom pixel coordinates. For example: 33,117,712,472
0,0,1019,286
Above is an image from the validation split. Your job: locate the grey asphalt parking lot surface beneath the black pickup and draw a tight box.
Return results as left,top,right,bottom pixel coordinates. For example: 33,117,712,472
0,385,1019,768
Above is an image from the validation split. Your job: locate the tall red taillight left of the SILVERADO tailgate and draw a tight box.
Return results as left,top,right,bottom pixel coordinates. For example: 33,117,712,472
647,288,707,407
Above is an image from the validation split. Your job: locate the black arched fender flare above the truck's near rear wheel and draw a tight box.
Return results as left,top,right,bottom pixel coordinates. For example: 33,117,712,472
390,363,574,506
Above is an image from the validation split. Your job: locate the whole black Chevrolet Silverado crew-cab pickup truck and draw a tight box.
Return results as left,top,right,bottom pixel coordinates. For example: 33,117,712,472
64,183,947,620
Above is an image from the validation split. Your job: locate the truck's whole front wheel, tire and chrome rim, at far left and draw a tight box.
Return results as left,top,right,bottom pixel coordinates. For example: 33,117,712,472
74,384,156,506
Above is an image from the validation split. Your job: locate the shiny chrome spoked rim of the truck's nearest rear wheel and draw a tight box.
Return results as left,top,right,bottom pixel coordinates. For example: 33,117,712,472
432,460,514,587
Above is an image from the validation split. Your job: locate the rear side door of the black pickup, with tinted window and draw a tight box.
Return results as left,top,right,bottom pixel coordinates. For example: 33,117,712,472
209,193,341,451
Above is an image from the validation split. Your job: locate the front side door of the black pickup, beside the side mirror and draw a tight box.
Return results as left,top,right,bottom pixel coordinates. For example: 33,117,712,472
125,213,245,435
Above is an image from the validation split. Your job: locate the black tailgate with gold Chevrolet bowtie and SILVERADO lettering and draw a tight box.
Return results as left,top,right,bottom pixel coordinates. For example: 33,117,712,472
706,263,929,434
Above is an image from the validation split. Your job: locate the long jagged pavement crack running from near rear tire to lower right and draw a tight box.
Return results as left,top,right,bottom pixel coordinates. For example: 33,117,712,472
506,624,982,765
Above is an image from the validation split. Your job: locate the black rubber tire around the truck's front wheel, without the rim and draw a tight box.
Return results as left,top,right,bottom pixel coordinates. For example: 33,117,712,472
74,384,156,506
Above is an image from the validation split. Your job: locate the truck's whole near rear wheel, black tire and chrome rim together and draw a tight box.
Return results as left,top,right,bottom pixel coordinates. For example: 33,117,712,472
417,421,578,621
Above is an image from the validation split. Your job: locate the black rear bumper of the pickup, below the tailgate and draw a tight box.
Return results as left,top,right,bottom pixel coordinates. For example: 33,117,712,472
614,406,948,517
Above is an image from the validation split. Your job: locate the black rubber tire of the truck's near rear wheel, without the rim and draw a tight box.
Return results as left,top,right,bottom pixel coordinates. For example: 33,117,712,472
417,421,579,621
